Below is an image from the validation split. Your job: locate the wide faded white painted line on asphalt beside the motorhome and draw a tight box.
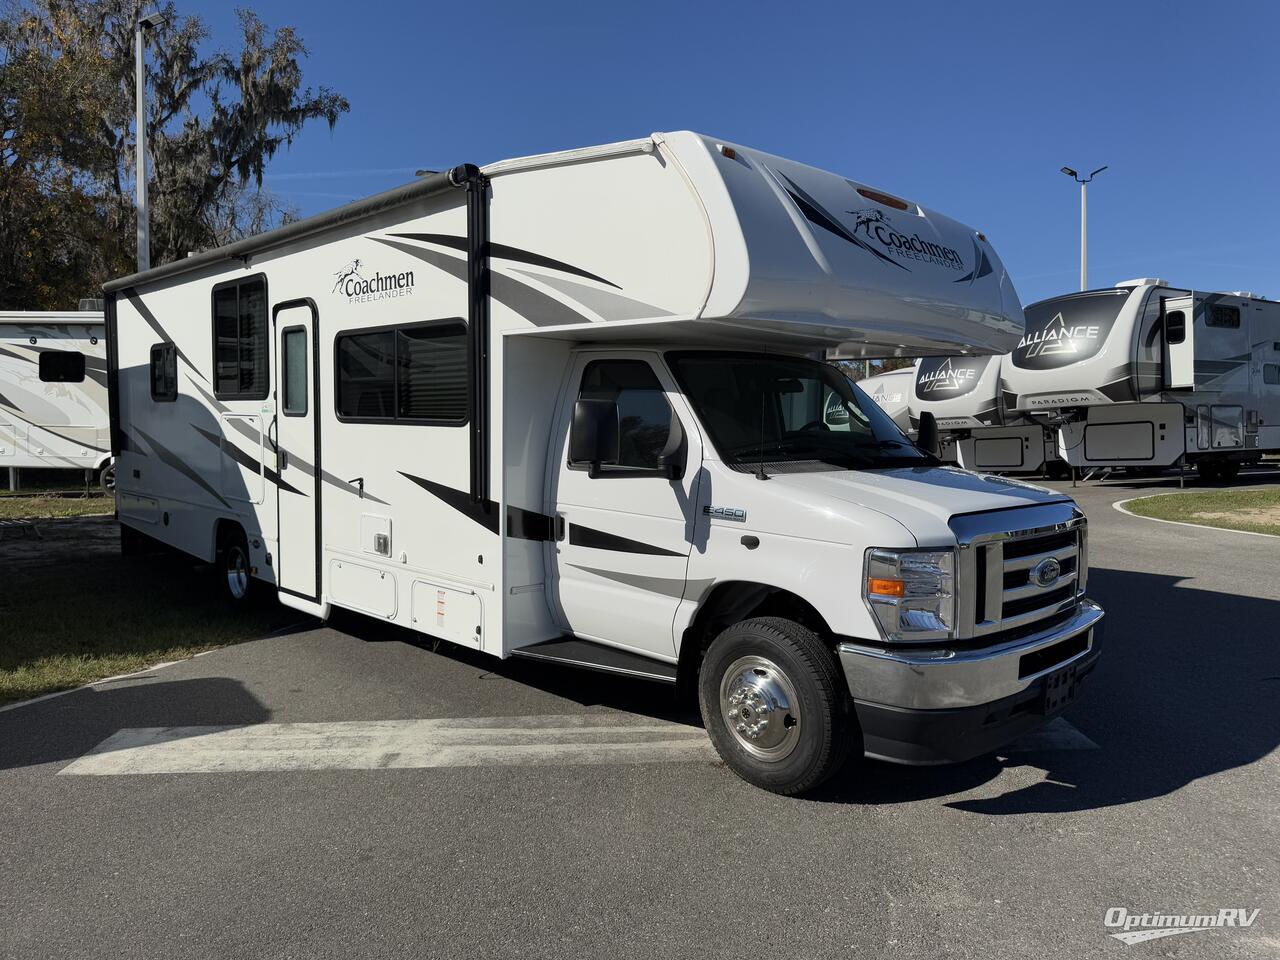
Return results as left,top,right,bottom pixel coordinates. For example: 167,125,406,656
60,714,716,776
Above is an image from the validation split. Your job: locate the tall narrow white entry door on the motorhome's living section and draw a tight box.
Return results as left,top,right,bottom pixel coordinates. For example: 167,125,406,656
274,300,320,600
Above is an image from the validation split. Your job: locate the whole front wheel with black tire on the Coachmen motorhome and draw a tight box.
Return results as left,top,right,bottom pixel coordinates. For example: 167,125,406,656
698,617,855,795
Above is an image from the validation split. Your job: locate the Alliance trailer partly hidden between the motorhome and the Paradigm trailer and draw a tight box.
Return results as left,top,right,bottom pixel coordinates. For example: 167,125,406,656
909,353,1064,474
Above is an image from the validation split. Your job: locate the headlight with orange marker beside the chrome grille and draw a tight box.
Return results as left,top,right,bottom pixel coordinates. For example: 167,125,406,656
863,548,956,643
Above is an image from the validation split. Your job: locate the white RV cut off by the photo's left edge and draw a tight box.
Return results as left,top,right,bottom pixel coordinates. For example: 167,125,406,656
0,311,111,485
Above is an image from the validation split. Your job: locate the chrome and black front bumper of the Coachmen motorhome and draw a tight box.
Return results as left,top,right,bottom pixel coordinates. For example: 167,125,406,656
840,600,1102,764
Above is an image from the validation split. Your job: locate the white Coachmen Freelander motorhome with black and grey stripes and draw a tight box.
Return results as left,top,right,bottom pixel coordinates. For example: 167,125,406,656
106,132,1102,794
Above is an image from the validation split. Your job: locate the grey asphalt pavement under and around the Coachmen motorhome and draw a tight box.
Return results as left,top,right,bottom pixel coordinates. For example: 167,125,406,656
0,472,1280,959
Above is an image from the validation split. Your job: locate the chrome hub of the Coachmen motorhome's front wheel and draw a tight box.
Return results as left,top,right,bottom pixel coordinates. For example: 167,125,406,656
719,655,800,762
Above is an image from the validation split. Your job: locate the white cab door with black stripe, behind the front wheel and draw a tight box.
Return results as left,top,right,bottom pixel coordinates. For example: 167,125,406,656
550,352,701,658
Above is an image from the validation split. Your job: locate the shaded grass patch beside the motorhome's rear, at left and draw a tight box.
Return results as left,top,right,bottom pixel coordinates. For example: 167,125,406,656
0,522,298,703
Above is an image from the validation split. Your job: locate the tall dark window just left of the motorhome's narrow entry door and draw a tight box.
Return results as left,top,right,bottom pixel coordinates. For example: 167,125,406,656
214,276,270,399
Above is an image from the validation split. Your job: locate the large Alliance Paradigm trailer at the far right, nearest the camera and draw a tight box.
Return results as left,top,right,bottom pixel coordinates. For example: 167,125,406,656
1001,279,1280,479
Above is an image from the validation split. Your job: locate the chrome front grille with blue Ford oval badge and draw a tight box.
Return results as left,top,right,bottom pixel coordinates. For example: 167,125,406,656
951,503,1088,640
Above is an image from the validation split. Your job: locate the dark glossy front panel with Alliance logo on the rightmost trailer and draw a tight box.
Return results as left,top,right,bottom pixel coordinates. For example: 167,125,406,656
1012,289,1129,370
